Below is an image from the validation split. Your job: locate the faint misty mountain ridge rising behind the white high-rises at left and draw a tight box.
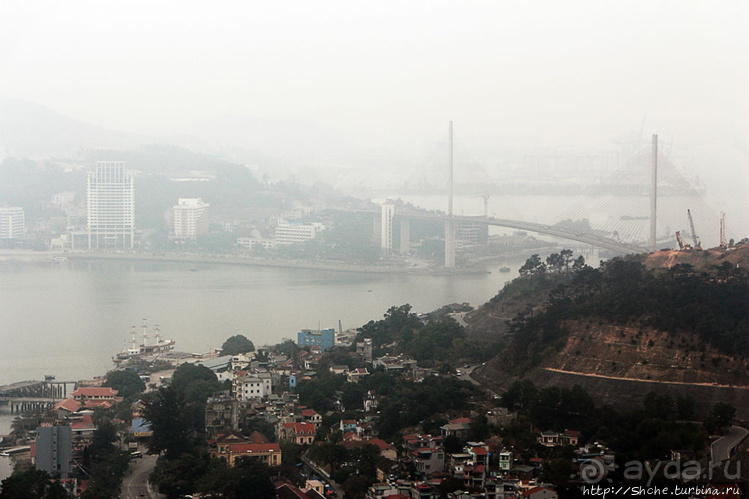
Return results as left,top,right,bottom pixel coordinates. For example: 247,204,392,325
0,97,394,184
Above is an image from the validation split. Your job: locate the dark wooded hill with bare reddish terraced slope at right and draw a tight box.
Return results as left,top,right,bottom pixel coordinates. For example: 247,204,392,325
469,244,749,412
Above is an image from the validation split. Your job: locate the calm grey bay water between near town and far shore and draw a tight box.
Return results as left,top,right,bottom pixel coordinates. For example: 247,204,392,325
0,258,525,385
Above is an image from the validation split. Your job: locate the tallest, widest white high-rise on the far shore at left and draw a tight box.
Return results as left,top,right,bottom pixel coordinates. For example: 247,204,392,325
86,161,135,249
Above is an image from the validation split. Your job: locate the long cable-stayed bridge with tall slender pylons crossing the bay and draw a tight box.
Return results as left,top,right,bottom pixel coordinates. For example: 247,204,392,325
374,136,731,267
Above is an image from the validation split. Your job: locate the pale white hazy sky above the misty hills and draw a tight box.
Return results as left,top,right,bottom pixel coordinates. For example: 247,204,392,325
0,0,749,146
